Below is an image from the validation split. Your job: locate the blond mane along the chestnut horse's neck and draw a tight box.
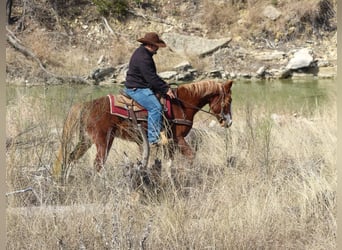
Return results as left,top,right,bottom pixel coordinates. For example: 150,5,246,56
179,80,222,96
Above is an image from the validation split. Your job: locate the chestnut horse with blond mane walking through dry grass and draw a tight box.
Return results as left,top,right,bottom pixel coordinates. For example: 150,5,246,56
52,80,233,180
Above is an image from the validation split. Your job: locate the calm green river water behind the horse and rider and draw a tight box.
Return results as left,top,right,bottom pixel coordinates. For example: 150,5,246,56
6,79,337,119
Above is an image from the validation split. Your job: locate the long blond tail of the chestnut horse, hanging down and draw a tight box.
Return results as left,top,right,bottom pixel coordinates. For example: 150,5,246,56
52,103,83,180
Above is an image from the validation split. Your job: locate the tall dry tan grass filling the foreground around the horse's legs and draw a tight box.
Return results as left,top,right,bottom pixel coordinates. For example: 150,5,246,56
6,89,337,249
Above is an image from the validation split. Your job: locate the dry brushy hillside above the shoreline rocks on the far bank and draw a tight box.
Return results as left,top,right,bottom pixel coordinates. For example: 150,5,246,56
6,0,337,84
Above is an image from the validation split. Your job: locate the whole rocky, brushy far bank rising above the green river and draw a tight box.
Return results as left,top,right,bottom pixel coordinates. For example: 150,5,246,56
6,0,337,85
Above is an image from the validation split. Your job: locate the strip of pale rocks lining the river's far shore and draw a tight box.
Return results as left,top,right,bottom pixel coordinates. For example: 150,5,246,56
110,33,337,82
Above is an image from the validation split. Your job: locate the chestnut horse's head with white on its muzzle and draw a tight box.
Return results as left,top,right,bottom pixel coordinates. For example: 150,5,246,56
209,80,233,128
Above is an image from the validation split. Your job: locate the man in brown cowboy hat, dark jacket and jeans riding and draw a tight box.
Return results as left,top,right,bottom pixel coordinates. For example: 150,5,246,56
125,32,175,146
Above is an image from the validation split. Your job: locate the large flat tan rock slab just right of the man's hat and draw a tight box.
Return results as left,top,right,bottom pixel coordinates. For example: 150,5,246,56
162,33,232,56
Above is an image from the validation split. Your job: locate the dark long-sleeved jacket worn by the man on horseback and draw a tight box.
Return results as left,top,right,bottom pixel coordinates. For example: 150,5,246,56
125,45,169,94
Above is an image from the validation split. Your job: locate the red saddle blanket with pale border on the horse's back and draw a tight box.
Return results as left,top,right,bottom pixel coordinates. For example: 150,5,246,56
107,94,172,120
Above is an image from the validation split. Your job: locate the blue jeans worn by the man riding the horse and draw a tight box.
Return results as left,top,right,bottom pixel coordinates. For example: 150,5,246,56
124,88,163,143
